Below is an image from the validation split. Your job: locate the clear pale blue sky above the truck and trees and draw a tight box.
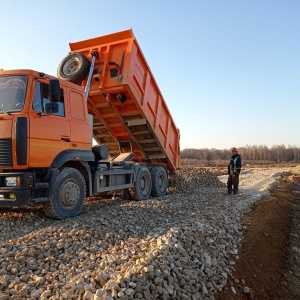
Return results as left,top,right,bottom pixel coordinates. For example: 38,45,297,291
0,0,300,150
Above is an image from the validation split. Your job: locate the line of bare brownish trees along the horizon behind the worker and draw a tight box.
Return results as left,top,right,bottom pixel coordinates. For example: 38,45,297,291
180,144,300,165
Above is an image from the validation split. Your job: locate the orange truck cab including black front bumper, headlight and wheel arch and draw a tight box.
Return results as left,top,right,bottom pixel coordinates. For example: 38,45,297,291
0,70,94,211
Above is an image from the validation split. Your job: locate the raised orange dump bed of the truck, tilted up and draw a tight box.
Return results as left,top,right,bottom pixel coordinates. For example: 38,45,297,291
66,30,180,173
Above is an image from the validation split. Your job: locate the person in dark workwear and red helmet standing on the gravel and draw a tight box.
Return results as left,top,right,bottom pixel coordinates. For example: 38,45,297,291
227,147,242,195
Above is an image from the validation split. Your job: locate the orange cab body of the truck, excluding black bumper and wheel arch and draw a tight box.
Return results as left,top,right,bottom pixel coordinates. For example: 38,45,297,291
0,70,92,170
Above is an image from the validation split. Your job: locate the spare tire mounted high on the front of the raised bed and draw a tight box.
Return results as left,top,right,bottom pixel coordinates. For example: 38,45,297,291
57,53,91,83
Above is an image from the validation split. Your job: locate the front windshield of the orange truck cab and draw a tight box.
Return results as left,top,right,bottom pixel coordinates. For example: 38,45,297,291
0,76,27,114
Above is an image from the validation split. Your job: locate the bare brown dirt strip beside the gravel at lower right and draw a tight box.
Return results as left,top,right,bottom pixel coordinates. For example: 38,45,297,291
216,173,300,300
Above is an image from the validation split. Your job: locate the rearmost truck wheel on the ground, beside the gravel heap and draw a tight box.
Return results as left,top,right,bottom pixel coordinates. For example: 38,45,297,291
150,167,168,197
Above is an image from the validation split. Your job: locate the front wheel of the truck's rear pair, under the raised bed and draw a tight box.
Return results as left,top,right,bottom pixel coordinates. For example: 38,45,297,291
130,167,152,201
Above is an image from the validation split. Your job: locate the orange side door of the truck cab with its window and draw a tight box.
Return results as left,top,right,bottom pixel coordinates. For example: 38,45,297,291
29,81,70,167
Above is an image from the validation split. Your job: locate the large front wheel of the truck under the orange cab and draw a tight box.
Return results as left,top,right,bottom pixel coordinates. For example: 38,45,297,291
44,168,86,220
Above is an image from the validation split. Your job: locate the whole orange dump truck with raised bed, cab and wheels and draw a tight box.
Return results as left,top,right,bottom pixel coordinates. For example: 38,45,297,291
0,30,180,219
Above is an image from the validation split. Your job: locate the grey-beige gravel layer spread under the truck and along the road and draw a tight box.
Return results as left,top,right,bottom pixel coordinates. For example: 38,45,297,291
0,168,290,300
